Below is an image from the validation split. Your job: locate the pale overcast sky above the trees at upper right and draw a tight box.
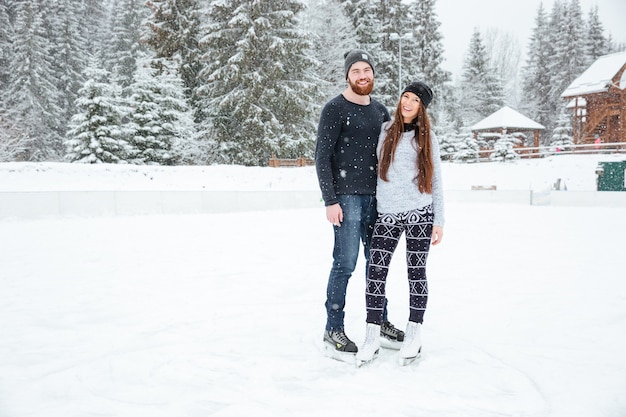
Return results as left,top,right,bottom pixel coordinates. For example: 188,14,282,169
436,0,626,77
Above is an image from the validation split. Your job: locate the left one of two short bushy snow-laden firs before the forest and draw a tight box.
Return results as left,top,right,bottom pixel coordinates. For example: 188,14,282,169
65,59,129,164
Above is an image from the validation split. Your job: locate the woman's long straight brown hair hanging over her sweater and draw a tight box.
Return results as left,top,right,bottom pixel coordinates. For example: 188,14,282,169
378,98,433,194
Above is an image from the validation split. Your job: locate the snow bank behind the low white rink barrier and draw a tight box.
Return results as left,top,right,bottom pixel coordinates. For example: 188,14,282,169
0,154,626,192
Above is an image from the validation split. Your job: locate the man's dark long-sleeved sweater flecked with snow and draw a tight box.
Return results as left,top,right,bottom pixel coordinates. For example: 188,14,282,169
315,94,390,206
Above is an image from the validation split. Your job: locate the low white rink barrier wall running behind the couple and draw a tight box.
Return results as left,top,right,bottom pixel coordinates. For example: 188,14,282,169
0,190,626,219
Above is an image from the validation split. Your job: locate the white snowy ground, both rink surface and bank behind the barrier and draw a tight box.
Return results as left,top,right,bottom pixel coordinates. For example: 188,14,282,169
0,157,626,417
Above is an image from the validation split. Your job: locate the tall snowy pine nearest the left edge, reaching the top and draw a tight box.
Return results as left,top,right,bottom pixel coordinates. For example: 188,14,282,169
4,0,64,161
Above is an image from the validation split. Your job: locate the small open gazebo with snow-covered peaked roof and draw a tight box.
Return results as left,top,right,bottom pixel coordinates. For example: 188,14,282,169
470,106,545,154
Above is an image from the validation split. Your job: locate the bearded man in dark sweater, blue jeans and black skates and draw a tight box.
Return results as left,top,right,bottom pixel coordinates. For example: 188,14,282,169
315,50,404,360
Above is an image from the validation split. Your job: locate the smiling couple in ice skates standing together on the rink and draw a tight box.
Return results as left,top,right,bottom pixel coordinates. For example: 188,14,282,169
315,50,444,364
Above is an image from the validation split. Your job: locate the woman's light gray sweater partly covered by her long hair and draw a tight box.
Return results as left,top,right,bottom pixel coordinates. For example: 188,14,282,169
376,121,445,227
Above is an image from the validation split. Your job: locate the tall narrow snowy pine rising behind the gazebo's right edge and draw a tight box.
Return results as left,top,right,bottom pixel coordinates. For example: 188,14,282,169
520,5,554,143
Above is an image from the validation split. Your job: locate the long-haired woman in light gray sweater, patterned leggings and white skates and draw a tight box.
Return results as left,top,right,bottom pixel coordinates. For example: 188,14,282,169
357,81,444,366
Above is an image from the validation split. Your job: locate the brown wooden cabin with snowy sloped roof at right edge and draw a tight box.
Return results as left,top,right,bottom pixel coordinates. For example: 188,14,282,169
561,51,626,144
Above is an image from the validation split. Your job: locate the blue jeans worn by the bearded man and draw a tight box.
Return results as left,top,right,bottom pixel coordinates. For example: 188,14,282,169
326,195,387,330
